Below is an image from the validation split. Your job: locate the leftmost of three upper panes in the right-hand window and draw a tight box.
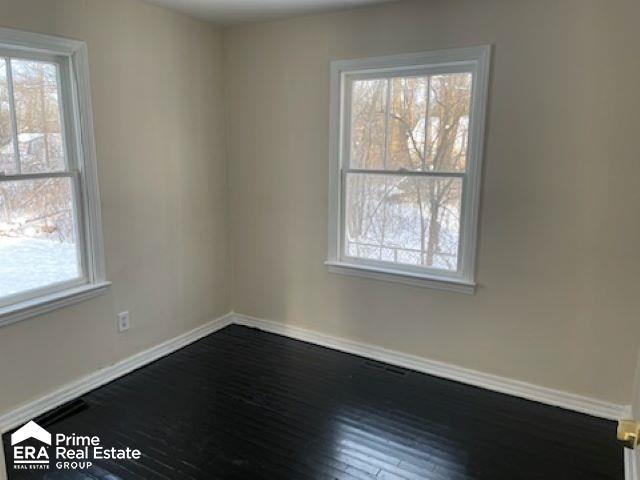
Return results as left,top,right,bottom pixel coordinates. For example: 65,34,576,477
351,79,388,169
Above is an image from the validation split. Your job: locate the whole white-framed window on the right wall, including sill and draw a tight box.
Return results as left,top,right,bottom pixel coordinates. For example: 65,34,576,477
327,47,490,293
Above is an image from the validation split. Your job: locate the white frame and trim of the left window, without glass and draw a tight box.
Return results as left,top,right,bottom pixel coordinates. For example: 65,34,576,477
0,28,111,327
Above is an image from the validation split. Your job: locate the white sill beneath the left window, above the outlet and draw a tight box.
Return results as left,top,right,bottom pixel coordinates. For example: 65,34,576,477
0,282,111,327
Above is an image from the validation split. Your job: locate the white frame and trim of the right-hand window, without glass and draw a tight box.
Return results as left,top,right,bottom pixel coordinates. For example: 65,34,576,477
325,45,491,294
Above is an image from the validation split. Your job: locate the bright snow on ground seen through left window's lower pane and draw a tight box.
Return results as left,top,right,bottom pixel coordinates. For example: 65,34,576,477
0,236,79,298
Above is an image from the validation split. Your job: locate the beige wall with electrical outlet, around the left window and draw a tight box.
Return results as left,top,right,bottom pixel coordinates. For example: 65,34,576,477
0,0,230,414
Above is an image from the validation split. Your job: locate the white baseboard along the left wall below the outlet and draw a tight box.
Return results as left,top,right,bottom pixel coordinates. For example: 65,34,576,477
0,313,233,434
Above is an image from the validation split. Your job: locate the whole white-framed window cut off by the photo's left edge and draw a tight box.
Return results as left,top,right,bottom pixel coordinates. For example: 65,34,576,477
0,29,108,325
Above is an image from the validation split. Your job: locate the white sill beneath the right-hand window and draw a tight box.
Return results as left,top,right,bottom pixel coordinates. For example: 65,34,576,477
325,261,476,295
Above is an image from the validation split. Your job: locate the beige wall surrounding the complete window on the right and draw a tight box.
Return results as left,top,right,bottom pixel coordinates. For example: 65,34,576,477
225,0,640,404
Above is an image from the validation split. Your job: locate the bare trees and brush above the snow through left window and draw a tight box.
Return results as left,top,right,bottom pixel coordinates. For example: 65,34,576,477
0,59,74,241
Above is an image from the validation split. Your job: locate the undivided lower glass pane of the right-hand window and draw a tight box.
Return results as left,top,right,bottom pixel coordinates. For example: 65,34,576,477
344,173,462,271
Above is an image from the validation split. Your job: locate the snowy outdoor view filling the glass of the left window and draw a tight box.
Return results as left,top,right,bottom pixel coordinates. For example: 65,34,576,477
0,57,82,305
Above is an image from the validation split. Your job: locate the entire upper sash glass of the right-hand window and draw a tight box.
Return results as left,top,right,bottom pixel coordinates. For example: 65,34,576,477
350,73,472,172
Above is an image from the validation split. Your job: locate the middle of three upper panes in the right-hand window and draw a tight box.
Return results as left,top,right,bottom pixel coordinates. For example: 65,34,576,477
387,77,429,170
